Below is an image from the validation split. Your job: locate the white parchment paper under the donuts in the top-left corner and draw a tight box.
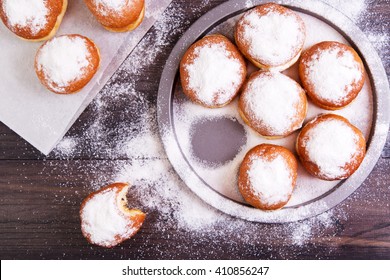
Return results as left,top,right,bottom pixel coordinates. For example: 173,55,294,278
0,0,172,154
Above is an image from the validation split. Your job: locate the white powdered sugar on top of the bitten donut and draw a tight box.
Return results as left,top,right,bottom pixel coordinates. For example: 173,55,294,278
81,189,134,245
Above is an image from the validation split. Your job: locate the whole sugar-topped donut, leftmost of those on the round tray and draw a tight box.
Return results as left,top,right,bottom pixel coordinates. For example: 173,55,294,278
180,34,246,108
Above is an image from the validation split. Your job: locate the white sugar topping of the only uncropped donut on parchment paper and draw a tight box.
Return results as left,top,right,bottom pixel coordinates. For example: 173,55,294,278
37,36,91,90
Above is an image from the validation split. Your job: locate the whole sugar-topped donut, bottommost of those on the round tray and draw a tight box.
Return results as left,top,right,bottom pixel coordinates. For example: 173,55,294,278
238,144,298,210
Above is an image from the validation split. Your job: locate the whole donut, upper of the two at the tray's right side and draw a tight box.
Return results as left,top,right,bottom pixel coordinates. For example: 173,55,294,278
299,42,364,110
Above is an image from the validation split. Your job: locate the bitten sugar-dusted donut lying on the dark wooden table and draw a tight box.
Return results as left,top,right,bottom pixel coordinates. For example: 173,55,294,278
80,183,146,248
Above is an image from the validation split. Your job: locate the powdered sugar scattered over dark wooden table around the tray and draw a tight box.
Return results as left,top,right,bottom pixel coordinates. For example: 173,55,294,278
51,0,390,259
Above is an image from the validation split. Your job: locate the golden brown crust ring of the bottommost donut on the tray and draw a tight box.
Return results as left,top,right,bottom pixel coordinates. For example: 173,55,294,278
238,144,298,210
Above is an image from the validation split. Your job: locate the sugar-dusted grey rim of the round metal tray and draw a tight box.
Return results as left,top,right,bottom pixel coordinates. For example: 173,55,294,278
157,0,390,223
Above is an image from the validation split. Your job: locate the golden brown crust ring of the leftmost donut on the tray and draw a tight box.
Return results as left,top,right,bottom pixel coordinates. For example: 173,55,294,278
180,34,247,108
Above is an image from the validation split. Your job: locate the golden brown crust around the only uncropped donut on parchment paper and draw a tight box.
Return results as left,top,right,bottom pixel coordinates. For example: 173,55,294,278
35,34,100,94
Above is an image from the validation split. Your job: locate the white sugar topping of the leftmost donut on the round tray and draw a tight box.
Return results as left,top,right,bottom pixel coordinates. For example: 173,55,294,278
184,43,243,106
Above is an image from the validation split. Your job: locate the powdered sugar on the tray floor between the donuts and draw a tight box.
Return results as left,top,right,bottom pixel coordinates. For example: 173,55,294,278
169,8,373,210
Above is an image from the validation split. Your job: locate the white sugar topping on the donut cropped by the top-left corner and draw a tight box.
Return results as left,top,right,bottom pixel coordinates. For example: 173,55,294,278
3,0,49,35
